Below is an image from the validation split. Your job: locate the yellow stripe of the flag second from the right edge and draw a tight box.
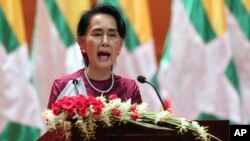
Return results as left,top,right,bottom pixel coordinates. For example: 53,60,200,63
202,0,226,36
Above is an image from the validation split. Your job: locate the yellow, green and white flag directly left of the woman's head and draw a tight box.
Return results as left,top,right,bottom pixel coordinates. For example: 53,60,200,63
31,0,90,108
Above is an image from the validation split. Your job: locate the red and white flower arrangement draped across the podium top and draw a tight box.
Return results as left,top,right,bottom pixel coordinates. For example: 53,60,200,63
42,94,220,141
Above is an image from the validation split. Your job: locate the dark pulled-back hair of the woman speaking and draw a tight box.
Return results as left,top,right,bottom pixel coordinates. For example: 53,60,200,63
77,4,126,66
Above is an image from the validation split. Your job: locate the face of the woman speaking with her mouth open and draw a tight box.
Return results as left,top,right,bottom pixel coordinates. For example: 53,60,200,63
80,14,123,69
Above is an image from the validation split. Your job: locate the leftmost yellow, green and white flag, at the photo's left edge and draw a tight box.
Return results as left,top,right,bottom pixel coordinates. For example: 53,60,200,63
0,0,43,141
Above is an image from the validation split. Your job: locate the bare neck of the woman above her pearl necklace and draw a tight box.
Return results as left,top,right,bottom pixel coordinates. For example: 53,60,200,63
85,67,111,81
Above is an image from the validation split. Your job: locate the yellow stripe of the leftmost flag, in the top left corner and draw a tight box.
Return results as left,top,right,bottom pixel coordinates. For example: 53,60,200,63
0,0,26,44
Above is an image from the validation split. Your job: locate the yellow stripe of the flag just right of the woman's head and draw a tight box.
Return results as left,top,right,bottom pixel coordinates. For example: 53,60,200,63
120,0,152,43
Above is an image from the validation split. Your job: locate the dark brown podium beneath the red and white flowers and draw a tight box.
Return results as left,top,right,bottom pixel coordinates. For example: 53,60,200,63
38,120,229,141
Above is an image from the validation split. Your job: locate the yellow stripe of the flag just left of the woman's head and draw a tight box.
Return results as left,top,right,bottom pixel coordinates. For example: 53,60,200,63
56,0,90,35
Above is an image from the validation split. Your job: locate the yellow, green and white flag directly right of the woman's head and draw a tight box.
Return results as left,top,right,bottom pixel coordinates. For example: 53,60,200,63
101,0,161,111
